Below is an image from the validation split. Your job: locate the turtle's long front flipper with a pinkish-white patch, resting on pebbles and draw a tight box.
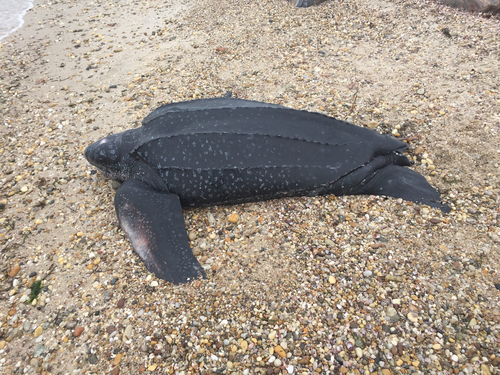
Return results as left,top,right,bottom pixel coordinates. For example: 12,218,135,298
115,177,206,284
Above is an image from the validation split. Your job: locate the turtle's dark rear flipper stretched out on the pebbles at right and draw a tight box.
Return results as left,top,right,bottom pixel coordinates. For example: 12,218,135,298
349,164,450,212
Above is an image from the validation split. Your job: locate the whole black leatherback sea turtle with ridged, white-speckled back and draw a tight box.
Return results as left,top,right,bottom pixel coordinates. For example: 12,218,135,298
85,98,448,284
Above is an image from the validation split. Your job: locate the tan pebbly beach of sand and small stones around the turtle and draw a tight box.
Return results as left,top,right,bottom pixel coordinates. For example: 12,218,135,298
0,0,500,375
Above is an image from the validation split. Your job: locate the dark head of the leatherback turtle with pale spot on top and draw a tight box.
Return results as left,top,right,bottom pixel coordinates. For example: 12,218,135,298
85,129,137,181
